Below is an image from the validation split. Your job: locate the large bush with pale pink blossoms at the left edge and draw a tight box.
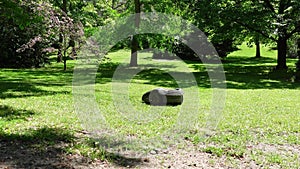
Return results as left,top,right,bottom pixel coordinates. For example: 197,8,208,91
0,0,83,67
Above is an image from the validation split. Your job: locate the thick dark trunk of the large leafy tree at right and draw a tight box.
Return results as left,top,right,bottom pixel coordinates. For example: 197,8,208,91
276,36,287,69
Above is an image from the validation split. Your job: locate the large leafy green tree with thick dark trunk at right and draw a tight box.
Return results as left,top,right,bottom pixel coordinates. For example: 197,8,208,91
211,0,300,69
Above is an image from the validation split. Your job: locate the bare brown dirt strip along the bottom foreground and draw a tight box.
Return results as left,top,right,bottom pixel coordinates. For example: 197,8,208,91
0,141,258,169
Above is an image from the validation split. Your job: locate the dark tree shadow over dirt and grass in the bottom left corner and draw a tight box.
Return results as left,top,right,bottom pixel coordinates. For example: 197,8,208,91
0,127,145,169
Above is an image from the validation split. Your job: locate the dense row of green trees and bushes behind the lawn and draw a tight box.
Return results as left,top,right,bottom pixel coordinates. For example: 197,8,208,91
0,0,300,69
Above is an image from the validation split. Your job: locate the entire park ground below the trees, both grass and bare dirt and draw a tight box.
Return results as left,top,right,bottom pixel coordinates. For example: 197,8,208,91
0,46,300,168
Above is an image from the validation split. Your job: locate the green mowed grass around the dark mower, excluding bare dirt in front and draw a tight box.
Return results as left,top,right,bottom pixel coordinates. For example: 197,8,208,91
0,46,300,168
